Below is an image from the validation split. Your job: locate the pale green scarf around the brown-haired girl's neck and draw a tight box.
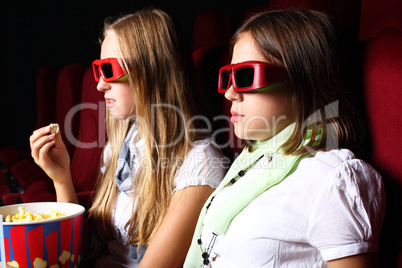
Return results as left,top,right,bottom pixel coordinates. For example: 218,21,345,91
184,123,321,268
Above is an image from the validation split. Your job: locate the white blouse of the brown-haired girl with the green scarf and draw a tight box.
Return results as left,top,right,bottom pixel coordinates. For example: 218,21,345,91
200,149,385,268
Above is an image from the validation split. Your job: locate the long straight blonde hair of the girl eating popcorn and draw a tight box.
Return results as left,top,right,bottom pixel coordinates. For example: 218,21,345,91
90,9,199,249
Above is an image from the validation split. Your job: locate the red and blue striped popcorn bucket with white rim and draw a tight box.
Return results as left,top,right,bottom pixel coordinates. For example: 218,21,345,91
0,202,85,268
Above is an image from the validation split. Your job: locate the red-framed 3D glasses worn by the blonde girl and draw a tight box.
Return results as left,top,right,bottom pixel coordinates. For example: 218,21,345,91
92,58,127,82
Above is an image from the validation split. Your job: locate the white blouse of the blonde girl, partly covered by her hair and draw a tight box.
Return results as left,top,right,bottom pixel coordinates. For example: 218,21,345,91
96,130,227,267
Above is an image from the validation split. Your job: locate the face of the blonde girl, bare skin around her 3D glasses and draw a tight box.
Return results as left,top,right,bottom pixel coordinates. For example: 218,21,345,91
97,32,135,119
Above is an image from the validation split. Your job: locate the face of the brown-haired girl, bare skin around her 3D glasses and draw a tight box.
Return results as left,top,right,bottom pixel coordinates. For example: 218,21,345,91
225,33,294,140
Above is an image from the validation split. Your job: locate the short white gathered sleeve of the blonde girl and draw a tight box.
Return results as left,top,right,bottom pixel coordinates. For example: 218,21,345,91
173,138,230,192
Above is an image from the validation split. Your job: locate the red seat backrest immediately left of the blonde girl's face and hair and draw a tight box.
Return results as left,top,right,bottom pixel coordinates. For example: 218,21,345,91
71,68,106,193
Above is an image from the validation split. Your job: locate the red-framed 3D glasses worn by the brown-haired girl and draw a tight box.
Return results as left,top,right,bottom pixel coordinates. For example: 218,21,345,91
218,61,289,93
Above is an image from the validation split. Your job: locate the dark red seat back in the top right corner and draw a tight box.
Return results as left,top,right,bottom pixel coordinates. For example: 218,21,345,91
359,0,402,41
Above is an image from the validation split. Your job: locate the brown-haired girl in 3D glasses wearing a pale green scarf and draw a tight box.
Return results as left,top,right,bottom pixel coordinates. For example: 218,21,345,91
184,10,385,268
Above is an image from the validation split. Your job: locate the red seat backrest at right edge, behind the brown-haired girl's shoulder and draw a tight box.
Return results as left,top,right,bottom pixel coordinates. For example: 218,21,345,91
363,29,402,182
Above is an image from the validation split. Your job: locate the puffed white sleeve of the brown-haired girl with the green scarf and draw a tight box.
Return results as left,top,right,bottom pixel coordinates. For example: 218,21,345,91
307,155,385,260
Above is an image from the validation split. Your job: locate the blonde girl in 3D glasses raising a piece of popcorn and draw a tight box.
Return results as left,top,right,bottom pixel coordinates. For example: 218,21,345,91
30,8,225,267
